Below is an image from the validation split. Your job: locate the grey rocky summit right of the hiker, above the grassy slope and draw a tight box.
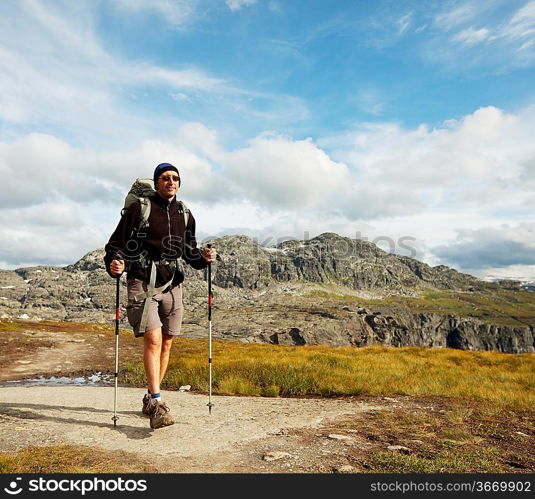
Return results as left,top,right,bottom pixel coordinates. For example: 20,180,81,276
205,233,490,292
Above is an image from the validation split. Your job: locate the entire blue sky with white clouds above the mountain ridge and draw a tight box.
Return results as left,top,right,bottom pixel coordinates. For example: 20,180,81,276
0,0,535,280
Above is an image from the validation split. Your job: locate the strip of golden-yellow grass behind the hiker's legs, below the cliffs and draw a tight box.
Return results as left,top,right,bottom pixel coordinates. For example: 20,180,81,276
119,338,535,407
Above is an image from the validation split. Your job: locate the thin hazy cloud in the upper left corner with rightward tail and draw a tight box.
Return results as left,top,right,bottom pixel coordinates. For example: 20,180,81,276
0,1,218,140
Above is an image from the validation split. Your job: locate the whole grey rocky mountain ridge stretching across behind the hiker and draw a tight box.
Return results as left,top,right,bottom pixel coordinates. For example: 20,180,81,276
0,233,534,353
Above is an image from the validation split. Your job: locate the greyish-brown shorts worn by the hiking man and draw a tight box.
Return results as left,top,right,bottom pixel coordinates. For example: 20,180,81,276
126,279,184,337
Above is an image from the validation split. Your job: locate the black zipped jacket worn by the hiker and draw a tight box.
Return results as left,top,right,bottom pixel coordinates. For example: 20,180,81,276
104,193,208,286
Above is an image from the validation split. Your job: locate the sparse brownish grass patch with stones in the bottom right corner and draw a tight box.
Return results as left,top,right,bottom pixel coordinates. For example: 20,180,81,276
354,398,535,473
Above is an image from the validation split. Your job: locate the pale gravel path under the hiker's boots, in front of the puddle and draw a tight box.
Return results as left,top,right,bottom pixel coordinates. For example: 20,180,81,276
0,386,392,472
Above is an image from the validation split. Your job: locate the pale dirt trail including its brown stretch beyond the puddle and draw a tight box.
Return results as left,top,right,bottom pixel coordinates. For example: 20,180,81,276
0,329,398,473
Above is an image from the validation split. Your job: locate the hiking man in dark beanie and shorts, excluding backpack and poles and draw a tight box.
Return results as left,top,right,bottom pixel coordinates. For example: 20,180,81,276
104,163,216,428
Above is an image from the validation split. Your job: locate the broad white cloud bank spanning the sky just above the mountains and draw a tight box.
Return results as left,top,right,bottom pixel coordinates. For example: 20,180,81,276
0,107,535,280
